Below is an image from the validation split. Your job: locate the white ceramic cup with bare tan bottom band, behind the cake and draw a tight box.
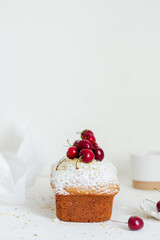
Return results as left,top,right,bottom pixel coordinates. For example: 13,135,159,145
131,151,160,190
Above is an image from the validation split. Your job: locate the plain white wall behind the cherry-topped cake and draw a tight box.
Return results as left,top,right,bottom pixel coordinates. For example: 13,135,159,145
0,0,160,175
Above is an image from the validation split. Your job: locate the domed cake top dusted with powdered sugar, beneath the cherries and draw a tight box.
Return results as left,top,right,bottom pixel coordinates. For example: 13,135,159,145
51,158,119,195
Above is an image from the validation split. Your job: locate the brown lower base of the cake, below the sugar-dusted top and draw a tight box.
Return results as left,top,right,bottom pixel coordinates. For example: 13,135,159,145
55,194,114,222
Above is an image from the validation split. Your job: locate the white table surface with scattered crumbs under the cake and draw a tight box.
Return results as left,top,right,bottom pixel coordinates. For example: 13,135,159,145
0,177,160,240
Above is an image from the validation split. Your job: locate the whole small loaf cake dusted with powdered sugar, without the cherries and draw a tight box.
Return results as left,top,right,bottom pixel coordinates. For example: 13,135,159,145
50,157,119,222
